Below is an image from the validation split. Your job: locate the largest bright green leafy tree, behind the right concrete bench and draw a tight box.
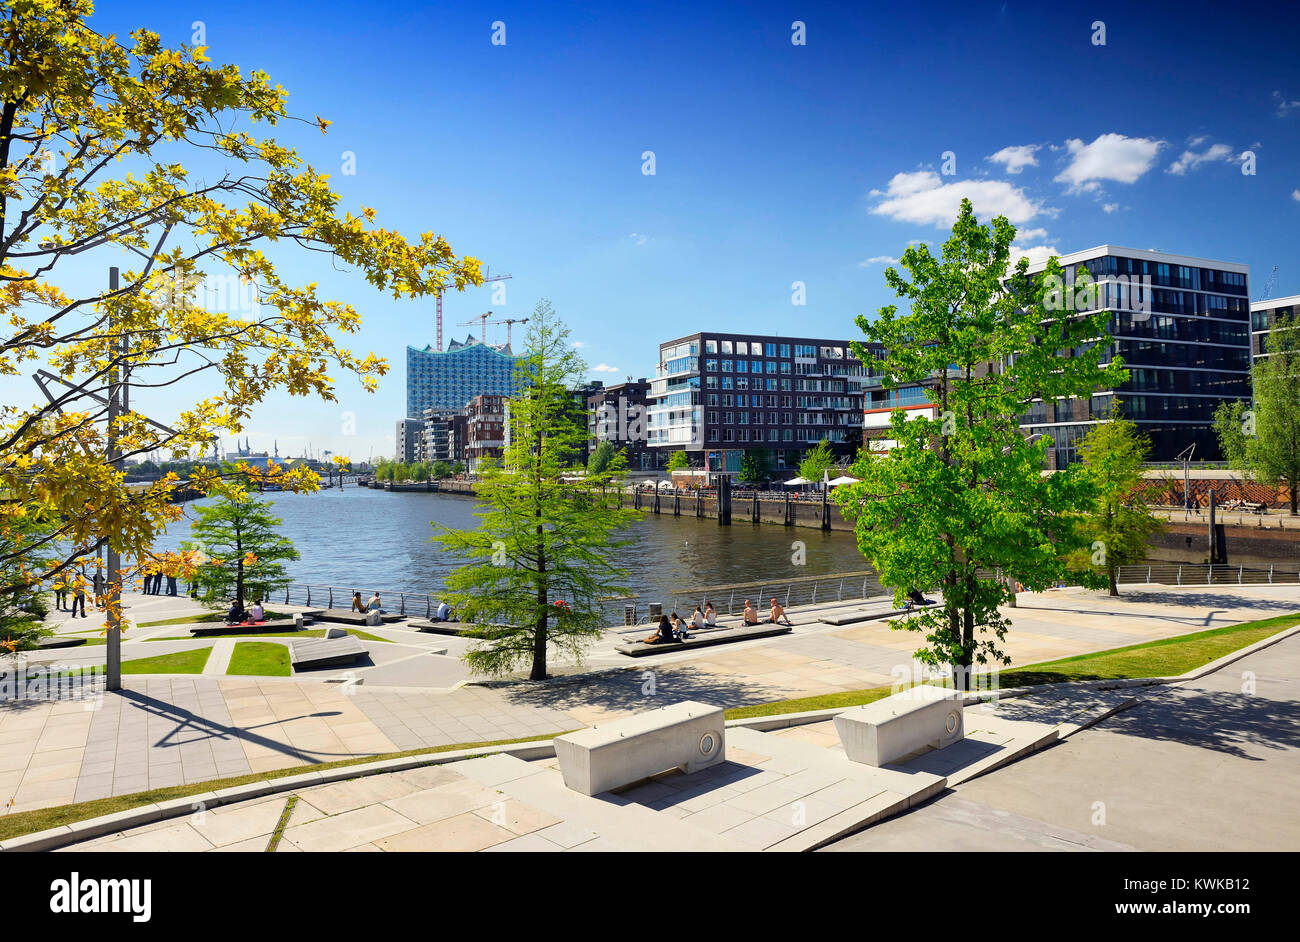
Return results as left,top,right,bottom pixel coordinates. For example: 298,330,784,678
835,199,1125,687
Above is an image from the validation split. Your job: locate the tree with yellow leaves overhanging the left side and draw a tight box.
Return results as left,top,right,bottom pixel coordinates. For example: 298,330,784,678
0,0,482,631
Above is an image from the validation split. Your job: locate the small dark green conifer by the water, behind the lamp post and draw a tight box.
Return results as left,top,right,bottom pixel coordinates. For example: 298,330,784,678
191,483,299,605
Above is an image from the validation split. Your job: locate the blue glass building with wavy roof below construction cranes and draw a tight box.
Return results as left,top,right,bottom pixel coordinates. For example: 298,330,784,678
407,335,519,418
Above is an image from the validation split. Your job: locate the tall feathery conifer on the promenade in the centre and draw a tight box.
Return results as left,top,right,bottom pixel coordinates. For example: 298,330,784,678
434,300,633,680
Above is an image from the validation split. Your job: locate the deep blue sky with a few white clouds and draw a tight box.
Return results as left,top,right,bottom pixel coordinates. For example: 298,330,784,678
5,0,1300,457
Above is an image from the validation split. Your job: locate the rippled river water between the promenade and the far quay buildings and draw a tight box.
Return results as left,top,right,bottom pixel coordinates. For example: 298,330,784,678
156,487,870,599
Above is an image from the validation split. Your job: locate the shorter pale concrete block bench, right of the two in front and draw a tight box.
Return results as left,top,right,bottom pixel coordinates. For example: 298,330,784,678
835,683,966,768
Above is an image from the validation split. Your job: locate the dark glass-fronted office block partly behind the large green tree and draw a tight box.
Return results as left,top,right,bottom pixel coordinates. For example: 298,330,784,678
1021,246,1251,468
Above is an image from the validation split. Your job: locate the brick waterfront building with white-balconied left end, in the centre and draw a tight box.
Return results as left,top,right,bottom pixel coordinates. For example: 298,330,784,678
647,333,868,474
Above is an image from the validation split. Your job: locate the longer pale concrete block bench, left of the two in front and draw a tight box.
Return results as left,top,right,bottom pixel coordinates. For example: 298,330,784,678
555,700,727,795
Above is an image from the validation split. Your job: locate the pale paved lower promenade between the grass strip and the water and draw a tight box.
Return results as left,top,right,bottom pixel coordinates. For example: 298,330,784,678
0,576,1300,811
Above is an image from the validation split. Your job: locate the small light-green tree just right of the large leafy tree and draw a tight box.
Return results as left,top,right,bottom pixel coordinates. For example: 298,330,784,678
1070,403,1165,595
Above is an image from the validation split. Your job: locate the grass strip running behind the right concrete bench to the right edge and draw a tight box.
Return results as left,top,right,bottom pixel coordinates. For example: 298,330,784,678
727,613,1300,720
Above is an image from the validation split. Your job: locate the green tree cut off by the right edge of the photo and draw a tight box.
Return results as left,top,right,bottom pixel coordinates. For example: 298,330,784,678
1214,316,1300,517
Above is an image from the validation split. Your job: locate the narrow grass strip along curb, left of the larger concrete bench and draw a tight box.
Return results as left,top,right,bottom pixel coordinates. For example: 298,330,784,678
0,730,572,841
